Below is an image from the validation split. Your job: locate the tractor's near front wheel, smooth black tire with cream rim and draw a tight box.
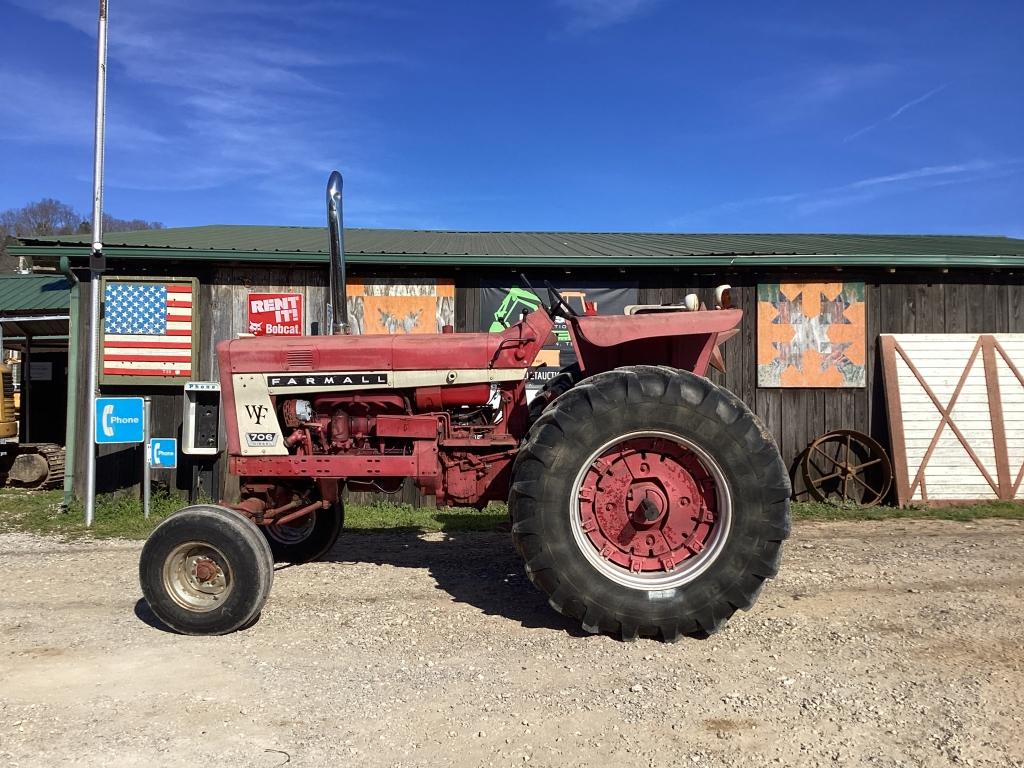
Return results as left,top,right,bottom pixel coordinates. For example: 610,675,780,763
138,505,273,635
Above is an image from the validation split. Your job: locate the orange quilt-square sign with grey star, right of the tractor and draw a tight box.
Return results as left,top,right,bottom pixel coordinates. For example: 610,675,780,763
758,283,866,387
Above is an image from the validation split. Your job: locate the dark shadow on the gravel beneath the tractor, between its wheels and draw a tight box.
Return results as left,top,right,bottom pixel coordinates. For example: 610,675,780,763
319,528,587,637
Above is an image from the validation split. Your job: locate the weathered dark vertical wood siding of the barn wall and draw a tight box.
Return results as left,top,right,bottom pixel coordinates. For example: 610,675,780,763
76,263,1024,503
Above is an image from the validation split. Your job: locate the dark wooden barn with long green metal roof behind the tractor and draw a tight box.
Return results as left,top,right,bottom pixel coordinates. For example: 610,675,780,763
11,226,1024,501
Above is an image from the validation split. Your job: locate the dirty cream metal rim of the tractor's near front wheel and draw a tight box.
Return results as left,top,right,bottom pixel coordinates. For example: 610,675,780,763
163,542,234,613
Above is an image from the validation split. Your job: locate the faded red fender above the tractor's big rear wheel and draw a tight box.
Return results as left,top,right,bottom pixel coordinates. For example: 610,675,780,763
568,309,743,376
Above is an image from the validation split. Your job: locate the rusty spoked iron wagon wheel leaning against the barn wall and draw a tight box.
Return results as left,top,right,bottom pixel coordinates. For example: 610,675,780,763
802,429,893,507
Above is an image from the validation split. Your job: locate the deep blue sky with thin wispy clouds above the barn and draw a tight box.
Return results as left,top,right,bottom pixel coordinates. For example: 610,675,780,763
0,0,1024,237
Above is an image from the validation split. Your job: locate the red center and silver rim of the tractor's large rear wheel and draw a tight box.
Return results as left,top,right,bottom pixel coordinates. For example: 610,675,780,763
569,430,733,592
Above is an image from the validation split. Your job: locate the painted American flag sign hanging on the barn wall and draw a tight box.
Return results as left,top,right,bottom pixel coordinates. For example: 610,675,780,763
101,278,196,384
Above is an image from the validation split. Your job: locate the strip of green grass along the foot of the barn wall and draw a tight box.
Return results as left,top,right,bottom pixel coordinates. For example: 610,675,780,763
0,488,1024,539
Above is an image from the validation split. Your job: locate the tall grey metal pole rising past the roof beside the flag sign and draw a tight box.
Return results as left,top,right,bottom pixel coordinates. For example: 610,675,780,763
81,0,106,527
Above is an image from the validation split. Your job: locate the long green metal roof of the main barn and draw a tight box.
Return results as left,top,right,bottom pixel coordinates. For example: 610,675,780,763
9,225,1024,267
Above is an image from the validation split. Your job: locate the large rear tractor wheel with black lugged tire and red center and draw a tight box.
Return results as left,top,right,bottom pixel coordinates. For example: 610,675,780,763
509,366,791,641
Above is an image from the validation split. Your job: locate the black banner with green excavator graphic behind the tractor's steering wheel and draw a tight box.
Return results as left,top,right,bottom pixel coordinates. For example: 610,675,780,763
480,280,639,389
